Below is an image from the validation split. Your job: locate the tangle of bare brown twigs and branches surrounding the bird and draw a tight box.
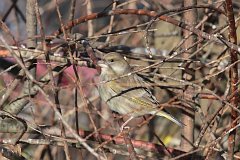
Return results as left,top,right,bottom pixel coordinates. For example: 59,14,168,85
0,0,240,160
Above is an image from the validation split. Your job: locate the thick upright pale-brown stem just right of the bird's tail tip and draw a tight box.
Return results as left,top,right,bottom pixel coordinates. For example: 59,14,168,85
181,0,198,151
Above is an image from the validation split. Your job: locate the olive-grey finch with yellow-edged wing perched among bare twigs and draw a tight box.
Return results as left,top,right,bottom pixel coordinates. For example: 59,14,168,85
98,52,183,130
